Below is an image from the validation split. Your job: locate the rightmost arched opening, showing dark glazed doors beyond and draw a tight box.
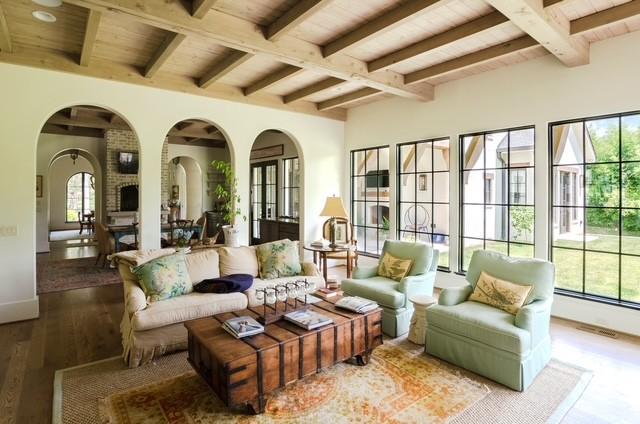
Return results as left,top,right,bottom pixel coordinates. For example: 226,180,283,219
249,129,304,244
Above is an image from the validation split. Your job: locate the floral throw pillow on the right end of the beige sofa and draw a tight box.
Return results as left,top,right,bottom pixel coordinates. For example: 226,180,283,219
256,239,302,280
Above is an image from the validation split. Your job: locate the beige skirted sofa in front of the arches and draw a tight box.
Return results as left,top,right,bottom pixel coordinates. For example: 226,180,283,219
116,246,325,368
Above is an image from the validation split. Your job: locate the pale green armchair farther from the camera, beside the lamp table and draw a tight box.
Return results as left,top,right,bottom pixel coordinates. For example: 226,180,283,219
342,240,438,337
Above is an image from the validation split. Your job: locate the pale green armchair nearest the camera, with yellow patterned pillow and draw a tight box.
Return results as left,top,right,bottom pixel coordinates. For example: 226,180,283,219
425,250,555,391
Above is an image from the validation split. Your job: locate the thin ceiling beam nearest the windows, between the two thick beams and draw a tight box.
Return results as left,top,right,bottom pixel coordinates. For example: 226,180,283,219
404,35,538,84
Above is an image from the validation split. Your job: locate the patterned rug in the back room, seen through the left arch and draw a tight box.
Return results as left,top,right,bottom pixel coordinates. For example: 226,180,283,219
36,254,122,294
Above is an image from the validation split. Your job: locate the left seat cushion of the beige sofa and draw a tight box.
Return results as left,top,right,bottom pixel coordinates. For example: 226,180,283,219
131,292,247,331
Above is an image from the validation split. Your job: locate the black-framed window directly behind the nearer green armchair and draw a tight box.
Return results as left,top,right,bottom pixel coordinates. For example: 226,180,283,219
460,127,535,271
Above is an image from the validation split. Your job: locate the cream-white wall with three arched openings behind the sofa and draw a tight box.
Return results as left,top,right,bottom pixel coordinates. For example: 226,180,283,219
0,64,344,323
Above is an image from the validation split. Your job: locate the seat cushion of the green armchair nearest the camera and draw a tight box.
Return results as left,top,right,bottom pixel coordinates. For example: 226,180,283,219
427,301,531,356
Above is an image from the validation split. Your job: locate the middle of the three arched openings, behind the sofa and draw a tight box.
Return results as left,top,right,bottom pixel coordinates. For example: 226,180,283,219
161,119,231,245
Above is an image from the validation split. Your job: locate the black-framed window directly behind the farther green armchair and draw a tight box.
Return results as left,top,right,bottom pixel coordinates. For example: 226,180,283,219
397,138,449,269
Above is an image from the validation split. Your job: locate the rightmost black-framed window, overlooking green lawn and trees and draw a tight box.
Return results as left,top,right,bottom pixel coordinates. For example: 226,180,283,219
549,112,640,304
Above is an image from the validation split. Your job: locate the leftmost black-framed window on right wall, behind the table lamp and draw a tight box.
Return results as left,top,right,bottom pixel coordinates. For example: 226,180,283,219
351,146,389,255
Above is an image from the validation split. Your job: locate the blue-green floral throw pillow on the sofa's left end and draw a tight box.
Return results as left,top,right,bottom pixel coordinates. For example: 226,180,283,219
131,253,193,302
